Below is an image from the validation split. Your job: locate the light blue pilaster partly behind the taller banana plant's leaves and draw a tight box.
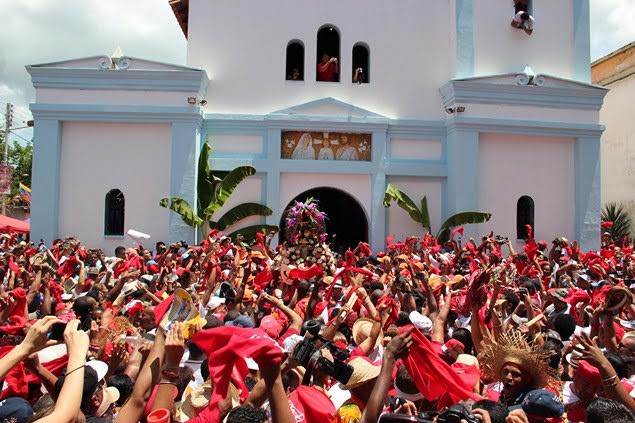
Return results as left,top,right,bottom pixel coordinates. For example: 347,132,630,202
170,122,200,244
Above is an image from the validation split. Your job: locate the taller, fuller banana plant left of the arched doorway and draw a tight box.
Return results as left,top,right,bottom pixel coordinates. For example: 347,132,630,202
159,143,278,239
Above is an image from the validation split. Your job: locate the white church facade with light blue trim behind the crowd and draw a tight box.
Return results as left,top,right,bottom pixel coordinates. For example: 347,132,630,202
27,0,606,249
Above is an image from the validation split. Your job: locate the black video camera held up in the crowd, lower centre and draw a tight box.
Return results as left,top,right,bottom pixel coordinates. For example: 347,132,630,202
293,320,353,385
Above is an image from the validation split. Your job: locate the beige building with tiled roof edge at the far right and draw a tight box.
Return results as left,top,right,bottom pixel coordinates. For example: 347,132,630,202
592,42,635,215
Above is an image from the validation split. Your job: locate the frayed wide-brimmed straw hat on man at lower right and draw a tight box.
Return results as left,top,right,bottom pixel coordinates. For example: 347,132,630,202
478,331,555,388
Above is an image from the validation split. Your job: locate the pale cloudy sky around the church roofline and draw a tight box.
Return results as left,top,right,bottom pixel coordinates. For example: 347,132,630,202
0,0,635,145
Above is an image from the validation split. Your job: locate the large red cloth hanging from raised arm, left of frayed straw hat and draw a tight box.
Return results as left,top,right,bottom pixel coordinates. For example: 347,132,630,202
403,328,480,403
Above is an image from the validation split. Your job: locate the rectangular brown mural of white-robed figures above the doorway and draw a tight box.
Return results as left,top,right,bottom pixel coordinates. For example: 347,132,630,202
281,131,372,162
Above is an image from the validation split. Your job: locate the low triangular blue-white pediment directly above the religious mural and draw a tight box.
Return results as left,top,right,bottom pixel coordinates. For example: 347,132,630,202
269,97,388,120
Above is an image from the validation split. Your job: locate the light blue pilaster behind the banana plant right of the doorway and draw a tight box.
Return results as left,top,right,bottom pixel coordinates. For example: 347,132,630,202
443,129,480,239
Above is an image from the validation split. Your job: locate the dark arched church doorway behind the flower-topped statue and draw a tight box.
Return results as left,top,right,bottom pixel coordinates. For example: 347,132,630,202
279,187,368,253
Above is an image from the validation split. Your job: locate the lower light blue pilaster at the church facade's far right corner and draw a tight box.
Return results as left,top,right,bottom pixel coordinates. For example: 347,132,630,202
575,137,602,251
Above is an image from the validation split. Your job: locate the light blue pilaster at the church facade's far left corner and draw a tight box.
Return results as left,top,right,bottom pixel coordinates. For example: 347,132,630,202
31,116,62,245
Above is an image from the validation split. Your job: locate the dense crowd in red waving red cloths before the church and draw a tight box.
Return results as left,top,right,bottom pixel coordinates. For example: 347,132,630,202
0,204,635,423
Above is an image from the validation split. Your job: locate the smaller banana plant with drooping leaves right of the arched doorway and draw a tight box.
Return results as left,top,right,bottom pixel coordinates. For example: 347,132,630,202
384,183,492,243
